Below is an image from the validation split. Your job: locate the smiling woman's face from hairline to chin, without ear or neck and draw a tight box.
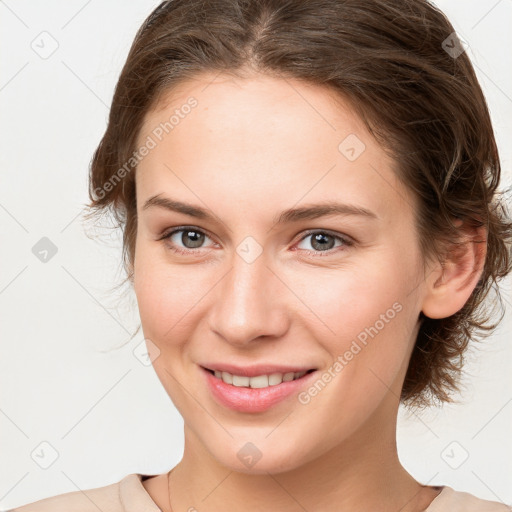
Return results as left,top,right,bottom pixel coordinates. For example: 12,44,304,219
134,75,424,473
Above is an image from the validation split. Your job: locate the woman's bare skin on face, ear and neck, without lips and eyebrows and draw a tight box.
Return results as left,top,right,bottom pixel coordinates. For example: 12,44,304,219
133,74,485,512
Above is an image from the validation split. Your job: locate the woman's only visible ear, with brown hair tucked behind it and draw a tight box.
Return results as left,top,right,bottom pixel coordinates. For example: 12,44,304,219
421,219,487,318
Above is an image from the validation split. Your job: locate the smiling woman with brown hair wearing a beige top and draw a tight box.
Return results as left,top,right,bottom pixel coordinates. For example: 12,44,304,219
16,0,512,512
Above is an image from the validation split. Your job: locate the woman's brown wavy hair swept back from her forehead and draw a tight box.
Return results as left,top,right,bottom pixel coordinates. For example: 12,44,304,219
87,0,512,407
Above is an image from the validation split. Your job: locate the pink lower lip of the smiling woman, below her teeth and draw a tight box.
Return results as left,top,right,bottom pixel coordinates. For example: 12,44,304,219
201,368,316,412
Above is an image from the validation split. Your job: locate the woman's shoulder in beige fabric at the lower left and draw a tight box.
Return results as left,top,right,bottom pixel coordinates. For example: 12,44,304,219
7,473,158,512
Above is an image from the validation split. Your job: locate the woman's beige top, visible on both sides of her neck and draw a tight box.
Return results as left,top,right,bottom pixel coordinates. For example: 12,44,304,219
7,473,512,512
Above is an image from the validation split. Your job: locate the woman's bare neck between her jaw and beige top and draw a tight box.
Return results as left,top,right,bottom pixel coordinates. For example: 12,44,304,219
171,393,438,512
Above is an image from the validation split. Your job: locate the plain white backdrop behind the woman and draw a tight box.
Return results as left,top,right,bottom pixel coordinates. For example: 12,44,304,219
0,0,512,509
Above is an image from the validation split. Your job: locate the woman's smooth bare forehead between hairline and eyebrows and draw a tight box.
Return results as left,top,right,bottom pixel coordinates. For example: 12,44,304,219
136,75,412,224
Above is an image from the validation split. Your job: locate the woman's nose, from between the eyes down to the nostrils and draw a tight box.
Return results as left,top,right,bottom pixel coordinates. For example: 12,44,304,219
210,249,290,346
